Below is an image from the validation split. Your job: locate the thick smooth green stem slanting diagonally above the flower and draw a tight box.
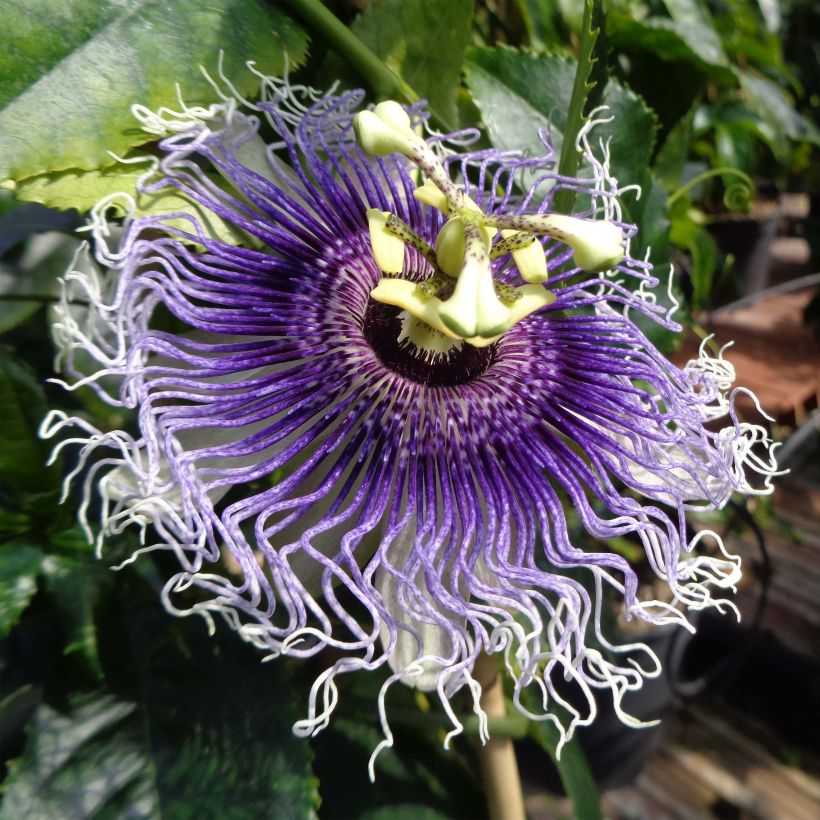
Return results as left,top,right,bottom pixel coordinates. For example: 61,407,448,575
285,0,419,103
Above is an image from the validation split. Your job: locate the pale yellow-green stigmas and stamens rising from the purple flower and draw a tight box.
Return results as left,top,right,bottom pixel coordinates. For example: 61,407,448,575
353,101,624,347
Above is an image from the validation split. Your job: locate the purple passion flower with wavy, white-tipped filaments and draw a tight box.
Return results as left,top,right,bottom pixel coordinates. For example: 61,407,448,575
43,70,775,768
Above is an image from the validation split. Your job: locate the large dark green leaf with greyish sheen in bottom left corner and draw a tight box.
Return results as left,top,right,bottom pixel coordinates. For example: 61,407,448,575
0,657,315,820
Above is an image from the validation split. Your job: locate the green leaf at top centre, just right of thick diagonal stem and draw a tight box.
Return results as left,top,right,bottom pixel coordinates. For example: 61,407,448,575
351,0,474,125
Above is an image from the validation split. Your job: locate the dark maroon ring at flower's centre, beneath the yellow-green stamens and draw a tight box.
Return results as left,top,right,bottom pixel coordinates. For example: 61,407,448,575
362,299,498,387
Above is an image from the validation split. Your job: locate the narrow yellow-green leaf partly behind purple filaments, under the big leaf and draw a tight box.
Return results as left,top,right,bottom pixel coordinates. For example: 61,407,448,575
16,164,251,245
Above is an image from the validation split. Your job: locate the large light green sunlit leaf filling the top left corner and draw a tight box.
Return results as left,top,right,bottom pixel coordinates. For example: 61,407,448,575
0,0,306,180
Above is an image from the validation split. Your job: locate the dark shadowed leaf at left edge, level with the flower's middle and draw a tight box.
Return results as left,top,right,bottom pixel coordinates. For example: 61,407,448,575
0,350,60,495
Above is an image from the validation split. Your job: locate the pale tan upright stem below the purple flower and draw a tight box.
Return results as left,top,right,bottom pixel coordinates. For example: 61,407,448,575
473,653,526,820
